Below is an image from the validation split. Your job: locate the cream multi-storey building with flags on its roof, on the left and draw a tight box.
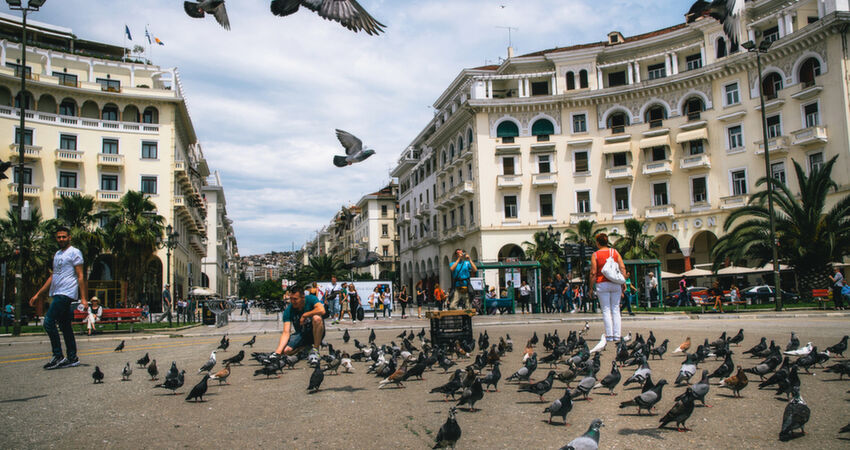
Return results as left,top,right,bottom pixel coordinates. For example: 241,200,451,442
0,14,235,311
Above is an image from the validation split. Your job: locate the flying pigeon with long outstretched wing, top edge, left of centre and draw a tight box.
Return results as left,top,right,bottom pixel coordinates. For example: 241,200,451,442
271,0,386,35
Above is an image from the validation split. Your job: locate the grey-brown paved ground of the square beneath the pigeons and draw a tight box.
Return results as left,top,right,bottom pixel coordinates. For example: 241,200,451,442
0,315,850,449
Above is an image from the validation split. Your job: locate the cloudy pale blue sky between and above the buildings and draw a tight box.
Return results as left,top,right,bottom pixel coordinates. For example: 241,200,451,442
21,0,692,256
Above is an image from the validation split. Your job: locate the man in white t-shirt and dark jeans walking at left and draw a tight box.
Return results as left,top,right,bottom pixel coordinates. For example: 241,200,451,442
30,226,89,370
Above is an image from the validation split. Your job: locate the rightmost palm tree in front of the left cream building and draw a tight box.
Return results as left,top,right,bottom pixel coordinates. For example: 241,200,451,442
104,191,165,304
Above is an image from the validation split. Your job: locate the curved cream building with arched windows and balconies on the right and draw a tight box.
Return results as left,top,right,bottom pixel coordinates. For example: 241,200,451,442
392,0,850,294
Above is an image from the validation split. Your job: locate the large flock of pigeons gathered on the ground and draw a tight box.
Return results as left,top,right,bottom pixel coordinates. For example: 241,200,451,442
81,322,850,449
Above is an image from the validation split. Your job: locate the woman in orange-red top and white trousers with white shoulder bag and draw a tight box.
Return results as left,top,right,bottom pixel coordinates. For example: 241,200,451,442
590,233,626,342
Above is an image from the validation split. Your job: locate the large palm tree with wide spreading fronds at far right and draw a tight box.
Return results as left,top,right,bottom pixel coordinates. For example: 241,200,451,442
712,156,850,297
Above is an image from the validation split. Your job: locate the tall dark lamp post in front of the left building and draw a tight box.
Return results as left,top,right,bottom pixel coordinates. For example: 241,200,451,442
6,0,46,336
